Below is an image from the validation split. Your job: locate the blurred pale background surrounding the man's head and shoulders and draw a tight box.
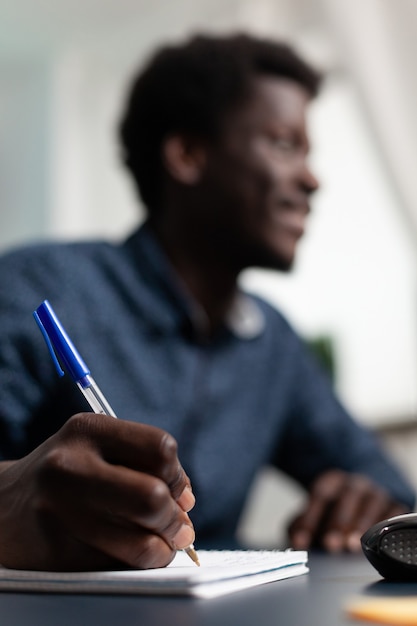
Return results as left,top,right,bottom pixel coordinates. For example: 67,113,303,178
0,0,417,543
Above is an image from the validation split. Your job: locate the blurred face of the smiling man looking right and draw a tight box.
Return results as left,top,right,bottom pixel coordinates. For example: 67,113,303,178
195,76,318,271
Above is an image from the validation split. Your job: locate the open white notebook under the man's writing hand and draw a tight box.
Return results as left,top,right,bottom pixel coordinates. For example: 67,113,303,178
0,550,308,598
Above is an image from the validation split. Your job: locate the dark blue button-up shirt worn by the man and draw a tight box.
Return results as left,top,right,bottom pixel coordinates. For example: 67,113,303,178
0,226,414,546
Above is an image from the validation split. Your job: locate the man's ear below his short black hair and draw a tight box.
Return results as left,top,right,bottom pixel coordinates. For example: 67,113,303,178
162,135,206,185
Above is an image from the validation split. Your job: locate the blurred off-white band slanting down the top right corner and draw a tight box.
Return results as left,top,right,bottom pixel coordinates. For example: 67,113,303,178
319,0,417,235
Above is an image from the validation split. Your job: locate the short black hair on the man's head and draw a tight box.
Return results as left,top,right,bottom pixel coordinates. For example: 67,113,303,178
120,33,321,213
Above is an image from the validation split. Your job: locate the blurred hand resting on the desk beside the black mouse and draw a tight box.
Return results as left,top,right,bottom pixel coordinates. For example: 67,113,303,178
288,470,409,552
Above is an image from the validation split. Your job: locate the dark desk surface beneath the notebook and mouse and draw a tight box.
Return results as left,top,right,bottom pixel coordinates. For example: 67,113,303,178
0,554,406,626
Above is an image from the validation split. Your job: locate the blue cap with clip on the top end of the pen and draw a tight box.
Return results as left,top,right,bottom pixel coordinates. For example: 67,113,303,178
33,300,90,382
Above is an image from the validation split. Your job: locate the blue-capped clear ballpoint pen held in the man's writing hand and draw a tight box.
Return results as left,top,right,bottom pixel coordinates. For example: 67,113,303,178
33,300,200,565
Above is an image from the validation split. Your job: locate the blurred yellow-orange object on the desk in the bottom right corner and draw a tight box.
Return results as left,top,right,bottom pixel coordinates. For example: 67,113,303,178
345,595,417,626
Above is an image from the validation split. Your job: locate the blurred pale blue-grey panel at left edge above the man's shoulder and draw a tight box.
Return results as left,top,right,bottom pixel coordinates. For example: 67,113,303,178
0,58,50,243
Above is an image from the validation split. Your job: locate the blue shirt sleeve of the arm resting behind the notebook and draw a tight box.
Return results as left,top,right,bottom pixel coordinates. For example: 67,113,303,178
274,334,415,509
